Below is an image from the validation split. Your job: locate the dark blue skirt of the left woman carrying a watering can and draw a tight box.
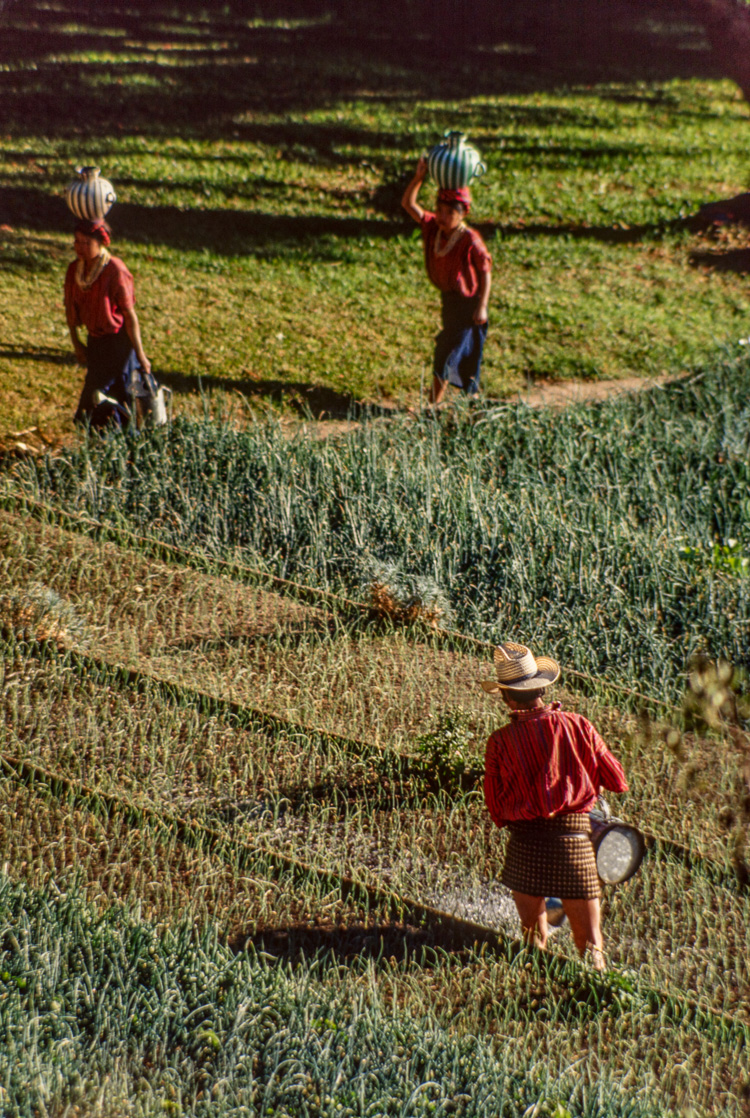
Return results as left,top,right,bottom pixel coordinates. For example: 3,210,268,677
74,325,137,427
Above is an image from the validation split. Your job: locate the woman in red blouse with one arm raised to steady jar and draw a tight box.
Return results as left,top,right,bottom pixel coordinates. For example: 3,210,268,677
401,157,492,404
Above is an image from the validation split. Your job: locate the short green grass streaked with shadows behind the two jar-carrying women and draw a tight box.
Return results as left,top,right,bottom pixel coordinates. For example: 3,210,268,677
0,3,750,438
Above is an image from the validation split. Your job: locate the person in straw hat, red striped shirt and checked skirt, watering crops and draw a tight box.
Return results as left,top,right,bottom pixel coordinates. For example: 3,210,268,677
482,641,628,970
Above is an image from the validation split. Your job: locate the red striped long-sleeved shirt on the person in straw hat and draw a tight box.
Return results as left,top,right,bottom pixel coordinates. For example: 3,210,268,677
484,702,628,827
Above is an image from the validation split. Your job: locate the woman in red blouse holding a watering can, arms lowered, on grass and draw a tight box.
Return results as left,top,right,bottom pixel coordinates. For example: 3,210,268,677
65,220,151,427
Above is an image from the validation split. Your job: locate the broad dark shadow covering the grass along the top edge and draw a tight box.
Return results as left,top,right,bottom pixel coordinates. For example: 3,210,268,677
0,0,720,144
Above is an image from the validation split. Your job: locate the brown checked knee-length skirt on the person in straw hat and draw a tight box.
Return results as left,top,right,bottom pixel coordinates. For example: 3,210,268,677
500,815,600,900
